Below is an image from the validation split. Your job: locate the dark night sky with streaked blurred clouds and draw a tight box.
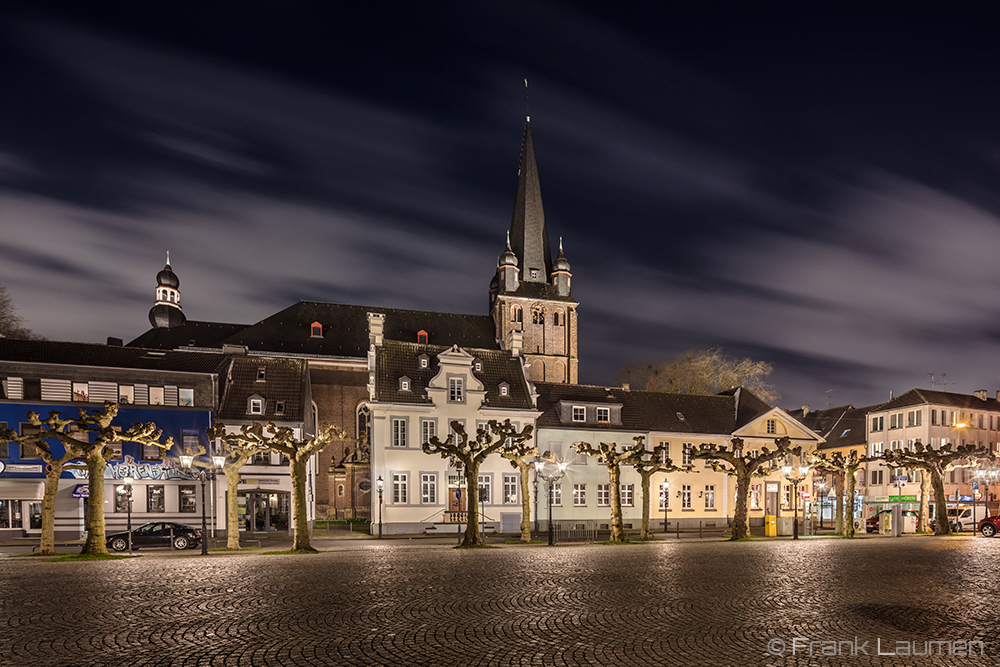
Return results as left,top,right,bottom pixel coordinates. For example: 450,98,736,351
0,2,1000,408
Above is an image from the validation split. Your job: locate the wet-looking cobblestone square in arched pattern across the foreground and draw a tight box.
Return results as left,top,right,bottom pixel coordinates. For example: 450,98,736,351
0,537,1000,667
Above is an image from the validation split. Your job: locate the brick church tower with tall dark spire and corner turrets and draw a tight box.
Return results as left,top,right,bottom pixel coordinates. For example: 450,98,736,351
490,116,579,384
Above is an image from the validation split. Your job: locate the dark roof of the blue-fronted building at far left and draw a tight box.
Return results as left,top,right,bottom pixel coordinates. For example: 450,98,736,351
0,338,229,375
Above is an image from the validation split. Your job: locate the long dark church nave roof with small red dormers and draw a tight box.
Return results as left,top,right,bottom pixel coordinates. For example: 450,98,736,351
129,301,498,359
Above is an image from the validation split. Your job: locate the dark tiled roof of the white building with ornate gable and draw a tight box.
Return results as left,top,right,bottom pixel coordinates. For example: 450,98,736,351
375,340,533,410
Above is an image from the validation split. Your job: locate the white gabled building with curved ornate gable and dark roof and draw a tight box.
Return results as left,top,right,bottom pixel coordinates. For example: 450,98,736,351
367,334,538,535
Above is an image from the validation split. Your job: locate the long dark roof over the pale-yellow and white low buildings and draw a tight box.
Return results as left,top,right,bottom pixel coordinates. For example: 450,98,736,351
535,383,752,435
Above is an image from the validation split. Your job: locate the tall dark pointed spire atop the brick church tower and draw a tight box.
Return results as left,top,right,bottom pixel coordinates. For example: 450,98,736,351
510,117,552,283
